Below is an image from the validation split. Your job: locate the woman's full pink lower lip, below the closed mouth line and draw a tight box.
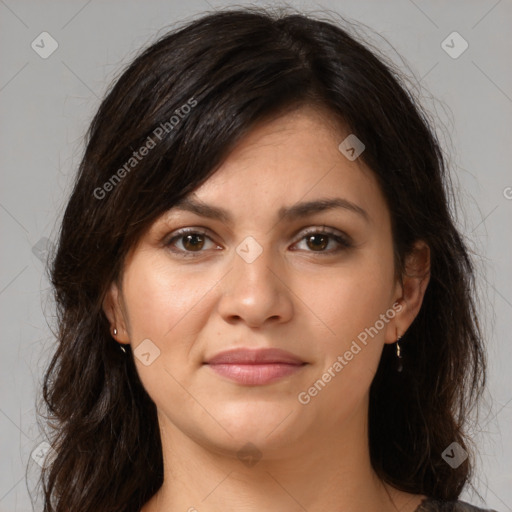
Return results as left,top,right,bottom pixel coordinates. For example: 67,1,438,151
208,363,305,386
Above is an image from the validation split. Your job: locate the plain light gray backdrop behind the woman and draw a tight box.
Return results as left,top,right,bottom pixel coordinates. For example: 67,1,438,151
0,0,512,512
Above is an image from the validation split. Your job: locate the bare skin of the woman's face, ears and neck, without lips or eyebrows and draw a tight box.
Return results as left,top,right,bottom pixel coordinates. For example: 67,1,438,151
104,107,430,512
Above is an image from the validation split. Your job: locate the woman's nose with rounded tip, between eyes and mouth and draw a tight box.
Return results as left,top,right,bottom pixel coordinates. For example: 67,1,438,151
218,239,293,327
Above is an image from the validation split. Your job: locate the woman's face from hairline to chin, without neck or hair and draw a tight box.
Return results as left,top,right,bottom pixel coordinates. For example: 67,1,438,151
109,108,422,458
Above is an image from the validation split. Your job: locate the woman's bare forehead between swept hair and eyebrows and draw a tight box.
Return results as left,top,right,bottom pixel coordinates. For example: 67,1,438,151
177,107,386,225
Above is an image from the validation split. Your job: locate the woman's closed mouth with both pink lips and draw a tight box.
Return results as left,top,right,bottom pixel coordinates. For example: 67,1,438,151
204,349,308,386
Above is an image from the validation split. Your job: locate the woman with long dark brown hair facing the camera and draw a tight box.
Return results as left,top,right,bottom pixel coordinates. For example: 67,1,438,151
38,9,498,512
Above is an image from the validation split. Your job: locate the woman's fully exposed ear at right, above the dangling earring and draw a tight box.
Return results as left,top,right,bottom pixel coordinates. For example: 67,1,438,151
385,240,430,343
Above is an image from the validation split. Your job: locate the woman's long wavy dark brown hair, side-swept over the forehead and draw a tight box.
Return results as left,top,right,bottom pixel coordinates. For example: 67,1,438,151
34,5,485,512
